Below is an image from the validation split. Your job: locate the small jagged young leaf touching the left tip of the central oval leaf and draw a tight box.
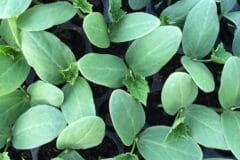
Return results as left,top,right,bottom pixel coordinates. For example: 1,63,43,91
60,62,78,85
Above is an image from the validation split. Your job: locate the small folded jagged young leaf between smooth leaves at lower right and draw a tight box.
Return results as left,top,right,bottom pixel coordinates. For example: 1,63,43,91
164,117,188,142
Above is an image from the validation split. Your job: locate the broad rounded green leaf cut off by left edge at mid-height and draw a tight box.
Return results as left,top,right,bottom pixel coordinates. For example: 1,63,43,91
0,46,30,96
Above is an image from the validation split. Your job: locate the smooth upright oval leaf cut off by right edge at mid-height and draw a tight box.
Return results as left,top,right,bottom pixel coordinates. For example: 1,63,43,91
218,56,240,108
